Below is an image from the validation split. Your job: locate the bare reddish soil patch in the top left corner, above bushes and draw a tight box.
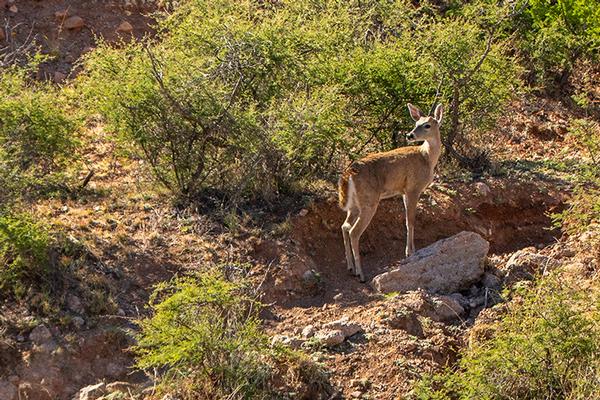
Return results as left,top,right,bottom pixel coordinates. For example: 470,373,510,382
0,0,156,81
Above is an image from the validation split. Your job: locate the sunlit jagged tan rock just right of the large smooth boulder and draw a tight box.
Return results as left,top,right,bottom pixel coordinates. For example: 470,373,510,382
503,248,561,287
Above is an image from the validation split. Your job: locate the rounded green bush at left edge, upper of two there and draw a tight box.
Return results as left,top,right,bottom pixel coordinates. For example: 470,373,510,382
0,63,78,199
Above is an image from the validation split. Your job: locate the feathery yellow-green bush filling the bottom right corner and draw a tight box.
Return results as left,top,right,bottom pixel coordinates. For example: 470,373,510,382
414,275,600,400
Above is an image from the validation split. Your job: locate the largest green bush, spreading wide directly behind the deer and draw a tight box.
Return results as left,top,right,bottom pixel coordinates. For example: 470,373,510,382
80,0,514,199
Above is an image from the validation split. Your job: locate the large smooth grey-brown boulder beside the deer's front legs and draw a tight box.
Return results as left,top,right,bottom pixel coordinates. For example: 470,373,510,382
372,232,490,293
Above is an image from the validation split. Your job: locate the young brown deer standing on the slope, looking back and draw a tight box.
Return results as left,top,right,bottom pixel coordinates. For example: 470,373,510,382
338,104,444,282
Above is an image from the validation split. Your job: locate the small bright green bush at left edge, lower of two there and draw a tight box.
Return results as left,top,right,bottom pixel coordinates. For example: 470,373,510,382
0,212,50,298
